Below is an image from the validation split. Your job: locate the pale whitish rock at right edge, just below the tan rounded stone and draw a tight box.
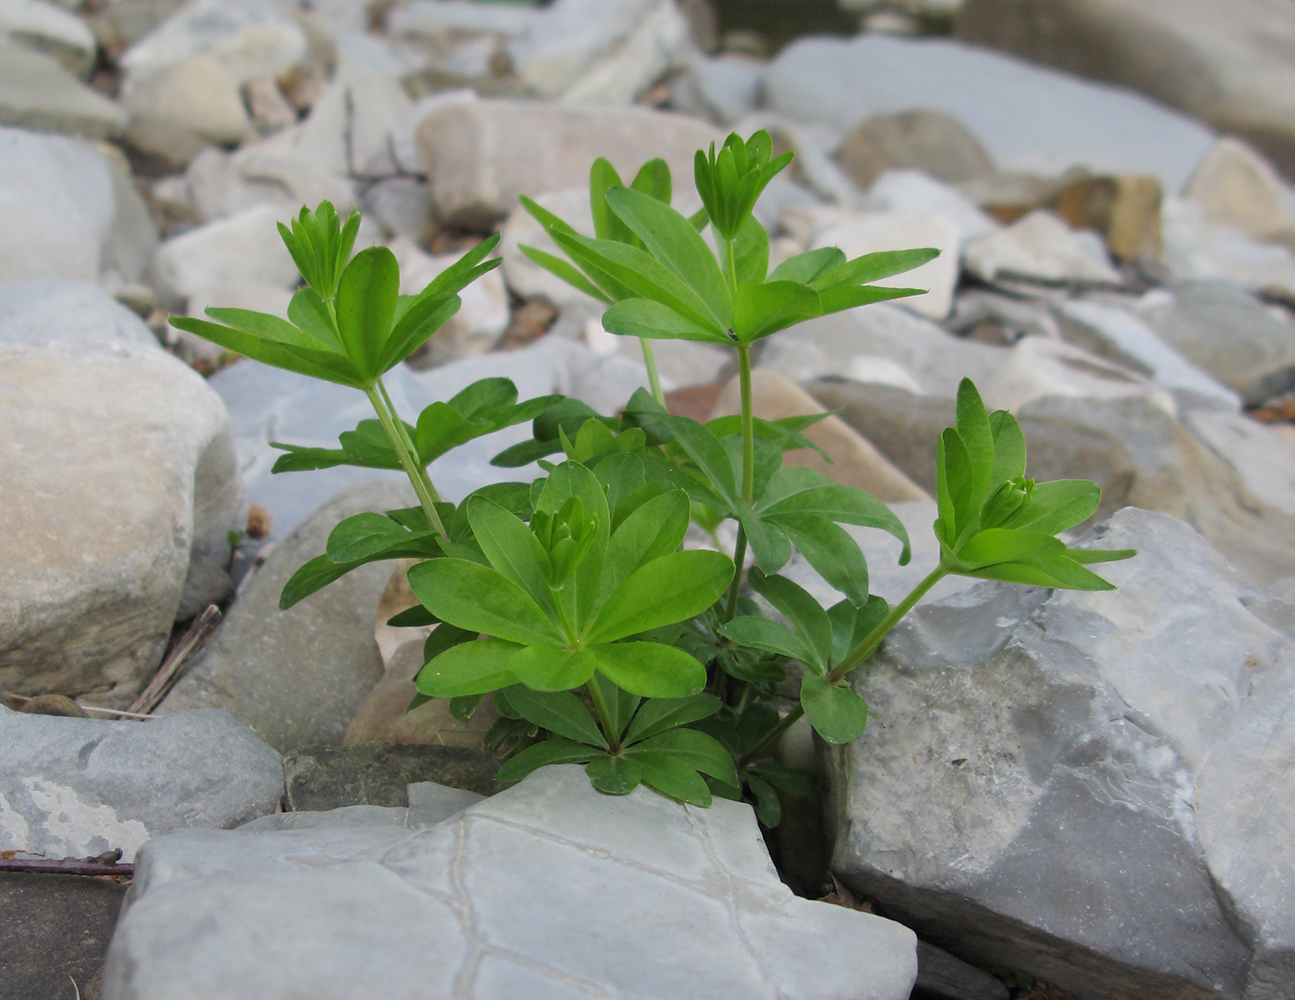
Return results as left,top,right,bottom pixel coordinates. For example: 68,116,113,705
1160,198,1295,295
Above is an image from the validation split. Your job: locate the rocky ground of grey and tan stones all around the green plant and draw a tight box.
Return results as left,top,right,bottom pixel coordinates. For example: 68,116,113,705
0,0,1295,1000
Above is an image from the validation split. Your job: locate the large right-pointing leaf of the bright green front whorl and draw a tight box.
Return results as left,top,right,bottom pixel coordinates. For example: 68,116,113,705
590,549,733,645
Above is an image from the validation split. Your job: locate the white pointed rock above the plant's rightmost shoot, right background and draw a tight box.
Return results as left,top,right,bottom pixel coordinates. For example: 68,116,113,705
976,337,1177,416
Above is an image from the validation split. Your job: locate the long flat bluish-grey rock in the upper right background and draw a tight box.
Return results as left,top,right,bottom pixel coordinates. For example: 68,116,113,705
765,35,1213,190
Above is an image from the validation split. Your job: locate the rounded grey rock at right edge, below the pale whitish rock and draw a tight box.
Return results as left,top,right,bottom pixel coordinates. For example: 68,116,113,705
1138,281,1295,407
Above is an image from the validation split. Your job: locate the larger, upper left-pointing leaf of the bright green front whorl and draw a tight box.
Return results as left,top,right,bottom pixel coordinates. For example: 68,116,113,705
408,558,563,645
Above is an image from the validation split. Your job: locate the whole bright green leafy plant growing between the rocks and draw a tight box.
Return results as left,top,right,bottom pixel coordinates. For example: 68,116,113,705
175,132,1133,825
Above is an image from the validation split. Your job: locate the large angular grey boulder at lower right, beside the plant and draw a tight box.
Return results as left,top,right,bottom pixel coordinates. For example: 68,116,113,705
830,509,1295,1000
